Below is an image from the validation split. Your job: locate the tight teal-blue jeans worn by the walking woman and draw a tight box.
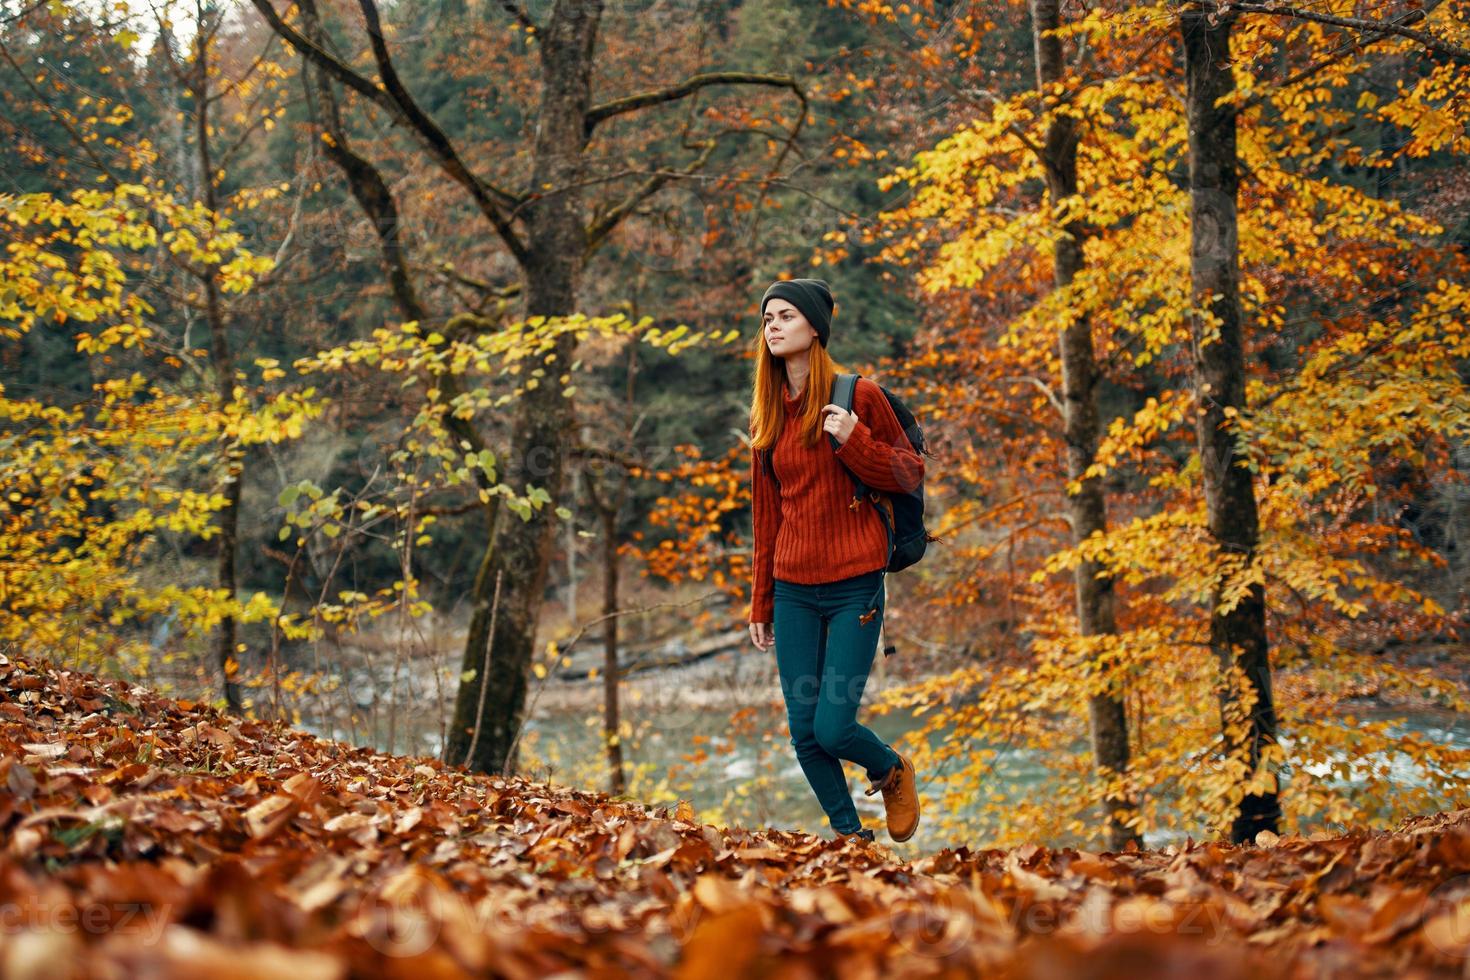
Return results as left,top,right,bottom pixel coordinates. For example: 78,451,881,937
772,569,898,833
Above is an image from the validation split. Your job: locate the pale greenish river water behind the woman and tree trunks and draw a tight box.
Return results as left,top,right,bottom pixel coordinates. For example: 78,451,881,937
505,652,1470,854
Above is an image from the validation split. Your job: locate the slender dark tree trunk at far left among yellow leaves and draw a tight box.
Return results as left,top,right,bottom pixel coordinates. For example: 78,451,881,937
194,22,244,713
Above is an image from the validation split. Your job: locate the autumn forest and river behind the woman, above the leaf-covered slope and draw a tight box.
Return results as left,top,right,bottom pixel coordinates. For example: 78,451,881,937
0,0,1470,846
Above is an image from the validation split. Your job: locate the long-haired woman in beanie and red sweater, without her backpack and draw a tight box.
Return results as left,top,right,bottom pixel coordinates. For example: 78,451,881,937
750,279,923,840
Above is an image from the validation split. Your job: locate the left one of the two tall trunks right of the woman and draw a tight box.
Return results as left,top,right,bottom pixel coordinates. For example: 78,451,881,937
1030,0,1142,851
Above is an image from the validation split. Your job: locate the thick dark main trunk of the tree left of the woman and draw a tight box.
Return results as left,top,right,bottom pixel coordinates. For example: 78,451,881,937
448,0,603,773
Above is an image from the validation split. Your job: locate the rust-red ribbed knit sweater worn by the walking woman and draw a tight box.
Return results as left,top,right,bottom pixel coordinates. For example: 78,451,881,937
750,378,923,623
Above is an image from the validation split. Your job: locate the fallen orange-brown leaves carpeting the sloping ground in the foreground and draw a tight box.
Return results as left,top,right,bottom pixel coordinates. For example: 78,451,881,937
0,657,1470,980
